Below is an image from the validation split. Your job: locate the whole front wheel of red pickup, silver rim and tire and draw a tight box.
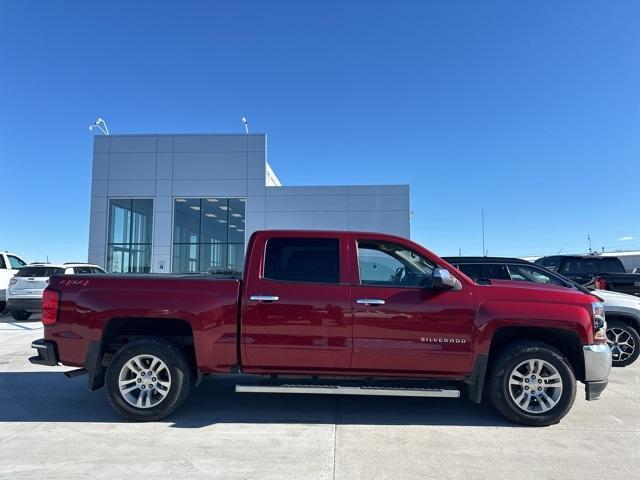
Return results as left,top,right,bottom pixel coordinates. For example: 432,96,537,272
488,342,576,427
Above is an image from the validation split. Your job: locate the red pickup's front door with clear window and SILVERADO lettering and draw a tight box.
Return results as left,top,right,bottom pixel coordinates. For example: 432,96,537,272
350,235,475,374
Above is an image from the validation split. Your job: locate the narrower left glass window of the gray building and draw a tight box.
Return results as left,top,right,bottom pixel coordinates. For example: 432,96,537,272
107,198,153,273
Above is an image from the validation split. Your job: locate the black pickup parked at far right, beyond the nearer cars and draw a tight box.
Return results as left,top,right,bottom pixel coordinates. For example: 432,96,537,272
536,255,640,297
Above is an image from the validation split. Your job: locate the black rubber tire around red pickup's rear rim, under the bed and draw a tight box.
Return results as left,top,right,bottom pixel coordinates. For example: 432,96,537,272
105,338,194,422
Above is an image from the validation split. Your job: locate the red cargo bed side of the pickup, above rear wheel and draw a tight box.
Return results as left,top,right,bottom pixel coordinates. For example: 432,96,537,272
46,274,241,372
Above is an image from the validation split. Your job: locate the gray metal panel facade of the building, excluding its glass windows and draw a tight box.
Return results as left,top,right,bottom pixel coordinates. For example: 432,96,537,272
88,134,410,272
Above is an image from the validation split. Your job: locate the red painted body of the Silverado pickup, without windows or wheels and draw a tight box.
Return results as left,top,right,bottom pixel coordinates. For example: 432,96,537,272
45,231,597,379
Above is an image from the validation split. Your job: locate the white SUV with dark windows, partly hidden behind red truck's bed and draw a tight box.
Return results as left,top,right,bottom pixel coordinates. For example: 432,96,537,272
7,263,107,320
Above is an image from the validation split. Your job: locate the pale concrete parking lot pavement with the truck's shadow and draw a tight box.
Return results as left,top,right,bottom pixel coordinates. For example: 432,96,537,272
0,315,640,480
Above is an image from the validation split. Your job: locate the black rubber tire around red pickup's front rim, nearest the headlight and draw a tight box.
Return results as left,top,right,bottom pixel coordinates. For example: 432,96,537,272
487,341,576,427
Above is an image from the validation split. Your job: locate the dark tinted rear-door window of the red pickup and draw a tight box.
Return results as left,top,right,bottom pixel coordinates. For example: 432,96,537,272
263,237,340,283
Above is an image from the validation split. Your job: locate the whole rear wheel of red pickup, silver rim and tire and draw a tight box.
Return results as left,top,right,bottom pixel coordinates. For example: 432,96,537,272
106,339,193,421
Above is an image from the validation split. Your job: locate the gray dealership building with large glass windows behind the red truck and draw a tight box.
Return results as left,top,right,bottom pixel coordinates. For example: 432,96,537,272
88,134,410,273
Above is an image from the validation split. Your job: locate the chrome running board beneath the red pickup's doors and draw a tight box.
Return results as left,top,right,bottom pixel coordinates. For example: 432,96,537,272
236,385,460,398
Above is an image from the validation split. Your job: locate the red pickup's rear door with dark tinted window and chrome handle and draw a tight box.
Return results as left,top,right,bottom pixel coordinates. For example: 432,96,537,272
241,232,352,372
